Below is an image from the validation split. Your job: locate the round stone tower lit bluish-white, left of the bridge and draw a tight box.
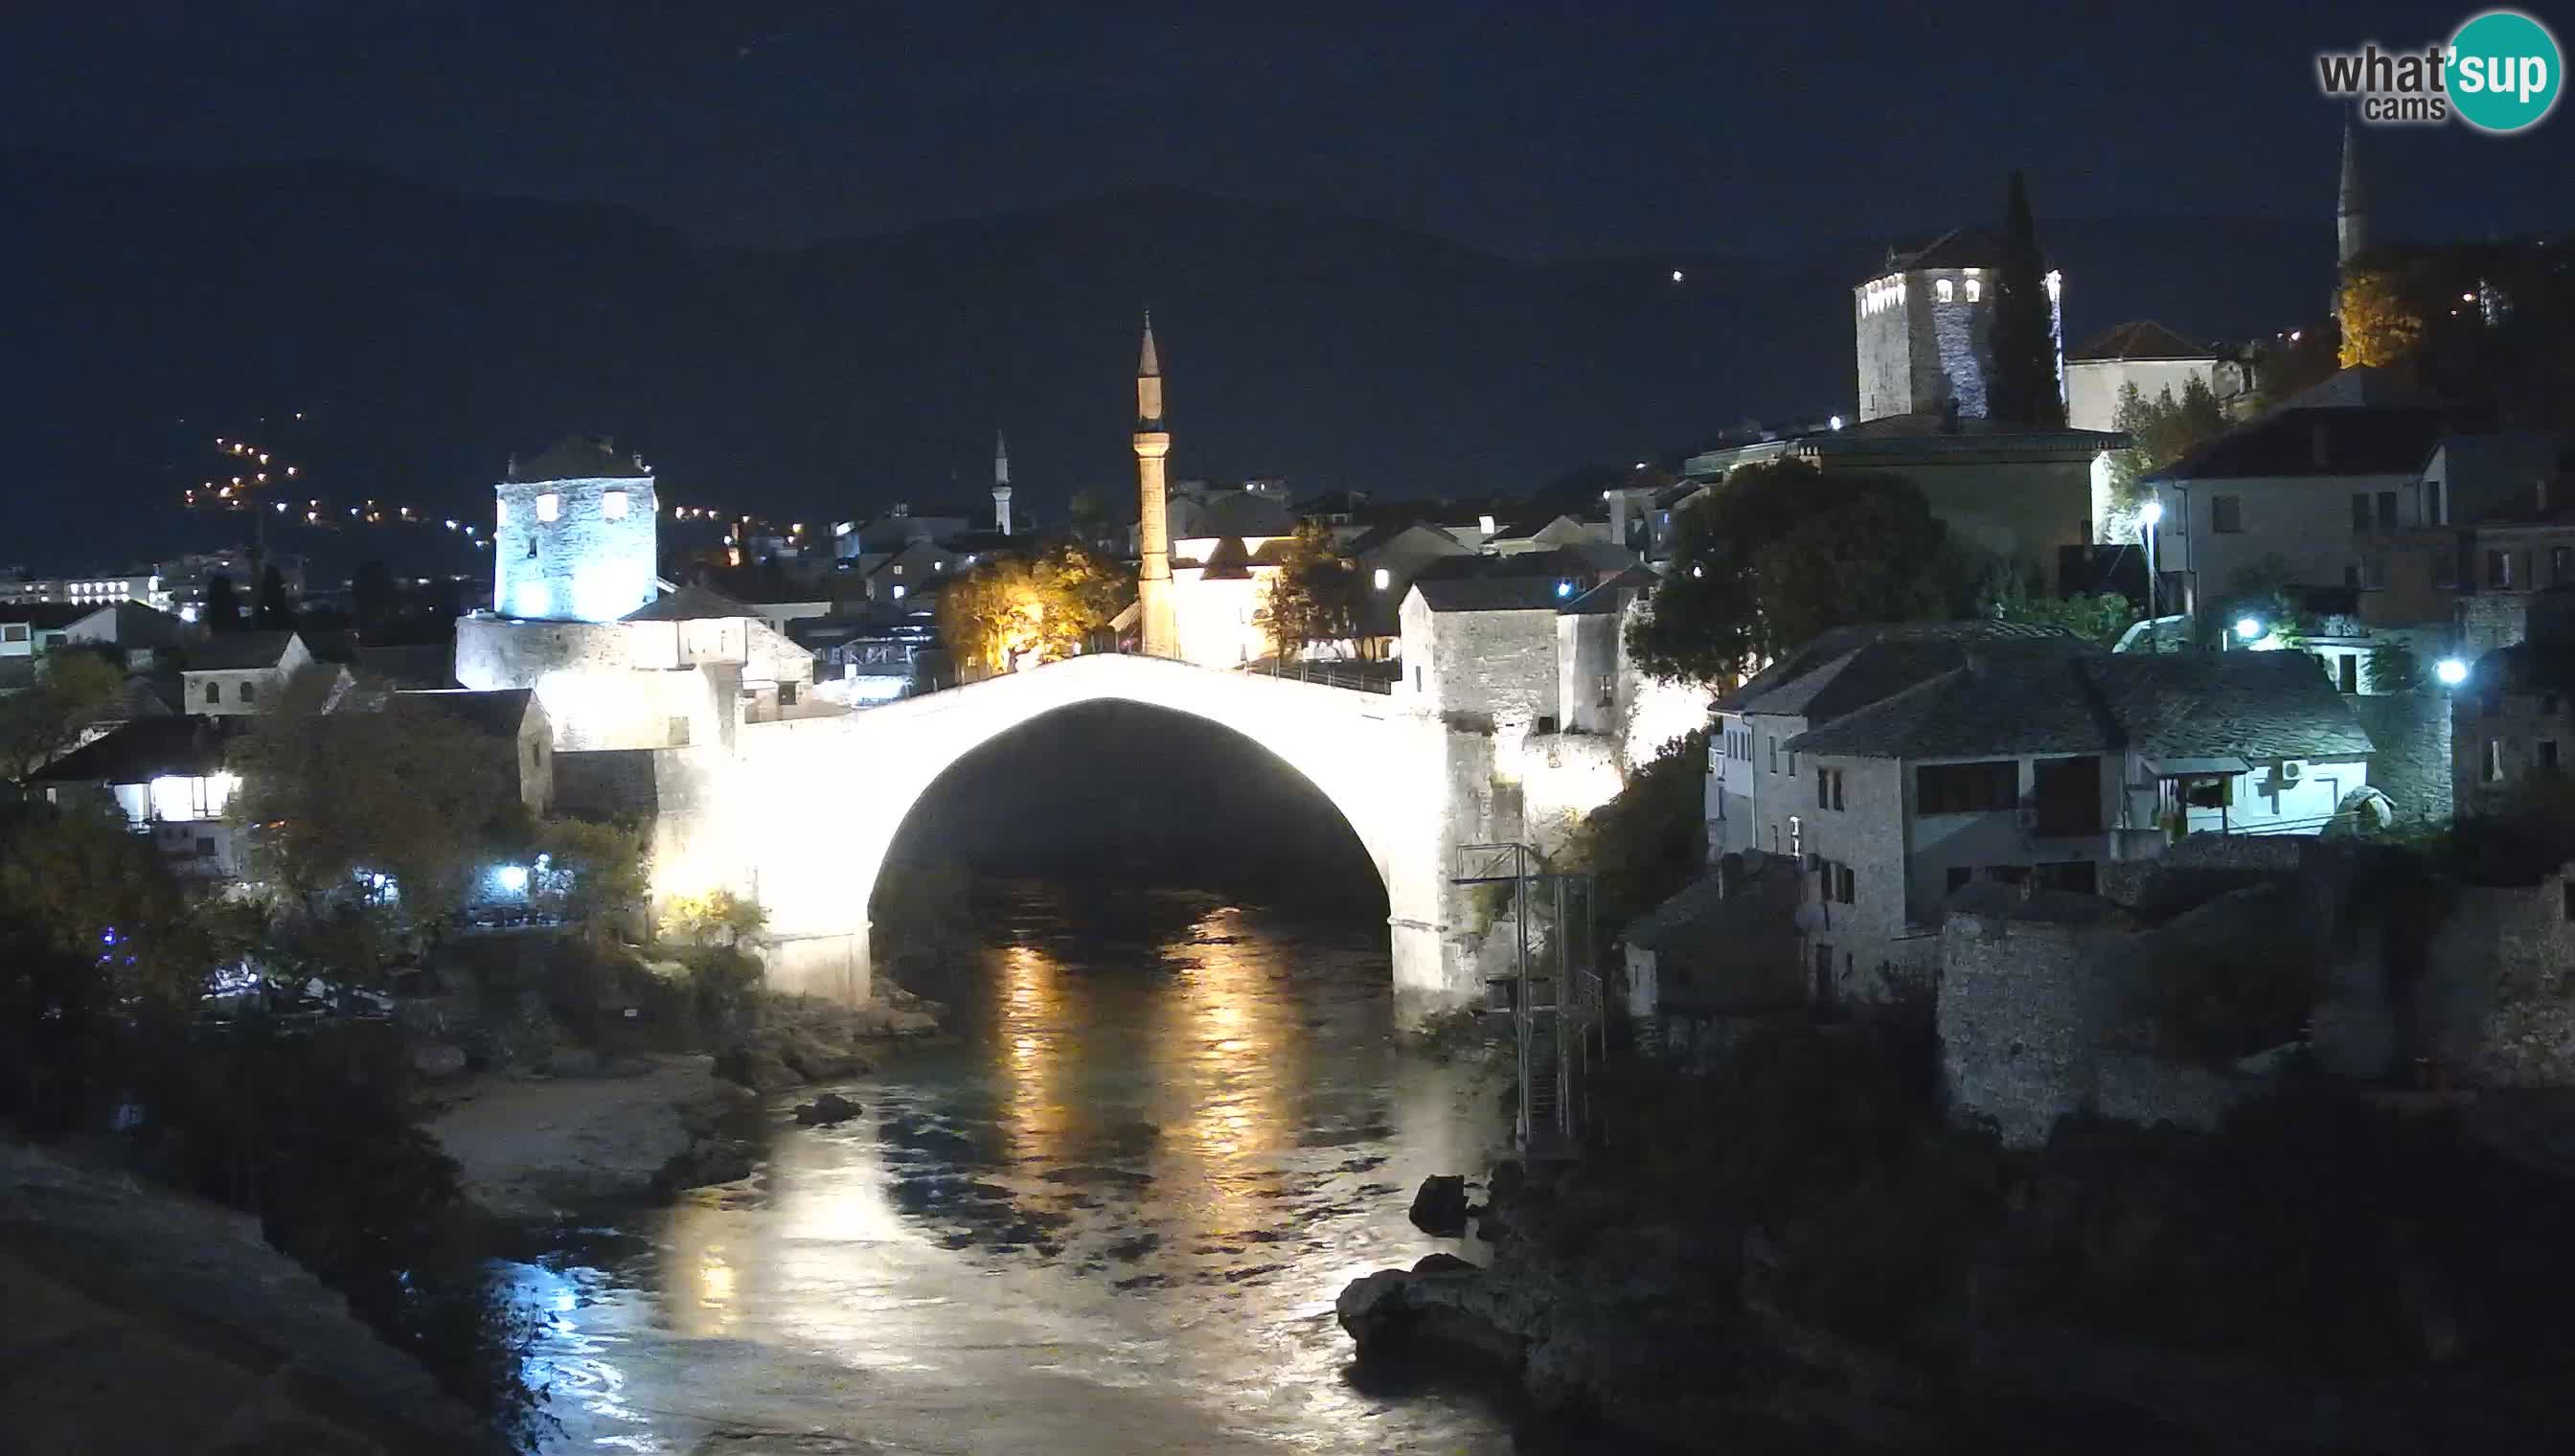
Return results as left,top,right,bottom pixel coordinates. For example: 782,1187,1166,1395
491,424,662,621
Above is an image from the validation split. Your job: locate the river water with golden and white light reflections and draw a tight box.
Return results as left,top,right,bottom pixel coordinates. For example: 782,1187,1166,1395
508,884,1581,1456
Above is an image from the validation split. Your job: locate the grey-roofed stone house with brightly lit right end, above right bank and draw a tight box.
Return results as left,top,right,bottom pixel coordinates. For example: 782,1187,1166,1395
1782,645,2374,1000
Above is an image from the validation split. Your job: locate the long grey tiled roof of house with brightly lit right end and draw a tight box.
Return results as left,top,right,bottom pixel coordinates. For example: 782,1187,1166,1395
1789,649,2374,761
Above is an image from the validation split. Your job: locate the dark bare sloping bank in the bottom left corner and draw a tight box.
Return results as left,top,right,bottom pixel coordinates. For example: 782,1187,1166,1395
0,1144,494,1456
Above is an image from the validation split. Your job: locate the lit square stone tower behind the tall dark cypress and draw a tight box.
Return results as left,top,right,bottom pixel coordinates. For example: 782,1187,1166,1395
1852,229,2065,422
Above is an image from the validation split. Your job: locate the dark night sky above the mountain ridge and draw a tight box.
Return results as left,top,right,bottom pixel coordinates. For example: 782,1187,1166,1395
0,0,2575,258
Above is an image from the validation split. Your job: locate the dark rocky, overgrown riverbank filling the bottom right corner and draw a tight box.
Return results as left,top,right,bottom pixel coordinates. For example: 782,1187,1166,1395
1336,1066,2575,1456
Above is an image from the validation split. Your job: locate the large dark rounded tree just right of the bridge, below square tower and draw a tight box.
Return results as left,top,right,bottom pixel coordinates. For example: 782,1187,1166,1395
1628,462,1965,683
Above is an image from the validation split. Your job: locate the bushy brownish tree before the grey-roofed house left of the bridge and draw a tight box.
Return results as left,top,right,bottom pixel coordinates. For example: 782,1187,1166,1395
232,670,517,920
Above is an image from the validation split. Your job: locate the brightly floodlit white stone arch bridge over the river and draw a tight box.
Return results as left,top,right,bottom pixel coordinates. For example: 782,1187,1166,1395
654,654,1516,1020
